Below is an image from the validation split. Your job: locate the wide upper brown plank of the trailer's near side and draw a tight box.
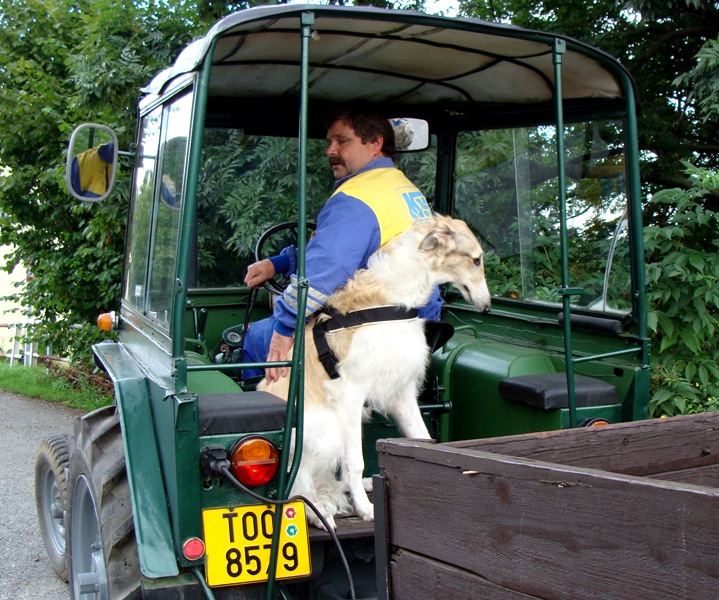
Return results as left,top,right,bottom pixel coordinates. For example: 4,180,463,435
378,439,719,600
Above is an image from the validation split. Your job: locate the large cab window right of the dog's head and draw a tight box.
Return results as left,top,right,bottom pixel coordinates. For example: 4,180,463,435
453,122,631,312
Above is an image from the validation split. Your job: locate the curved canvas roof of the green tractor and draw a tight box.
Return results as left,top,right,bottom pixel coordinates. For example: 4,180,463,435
143,5,633,110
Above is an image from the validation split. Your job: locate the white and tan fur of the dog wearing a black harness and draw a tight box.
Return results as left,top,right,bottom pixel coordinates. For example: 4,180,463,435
259,216,490,527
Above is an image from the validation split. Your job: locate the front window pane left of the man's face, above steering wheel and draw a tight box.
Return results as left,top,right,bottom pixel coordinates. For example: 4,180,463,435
191,127,334,288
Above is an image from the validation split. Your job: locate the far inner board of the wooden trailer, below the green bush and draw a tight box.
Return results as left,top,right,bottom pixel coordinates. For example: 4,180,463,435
446,413,719,476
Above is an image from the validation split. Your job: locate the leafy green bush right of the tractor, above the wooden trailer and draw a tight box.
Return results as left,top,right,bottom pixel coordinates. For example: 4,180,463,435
644,165,719,415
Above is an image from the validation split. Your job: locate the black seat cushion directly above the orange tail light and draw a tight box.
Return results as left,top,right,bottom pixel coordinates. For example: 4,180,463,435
197,392,287,435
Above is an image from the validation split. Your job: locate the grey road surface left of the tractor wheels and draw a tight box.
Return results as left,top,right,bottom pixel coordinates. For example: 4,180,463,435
0,391,80,600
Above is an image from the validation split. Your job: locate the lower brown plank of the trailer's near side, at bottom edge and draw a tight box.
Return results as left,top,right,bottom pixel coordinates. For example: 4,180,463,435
390,550,537,600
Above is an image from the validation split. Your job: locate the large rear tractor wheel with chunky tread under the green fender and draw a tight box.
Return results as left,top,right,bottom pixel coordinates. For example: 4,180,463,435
66,406,142,600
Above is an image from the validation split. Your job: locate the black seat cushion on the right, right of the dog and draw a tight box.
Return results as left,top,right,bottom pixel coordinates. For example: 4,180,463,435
499,373,617,410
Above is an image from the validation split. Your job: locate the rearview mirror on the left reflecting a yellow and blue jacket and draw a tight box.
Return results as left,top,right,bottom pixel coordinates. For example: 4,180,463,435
65,123,117,202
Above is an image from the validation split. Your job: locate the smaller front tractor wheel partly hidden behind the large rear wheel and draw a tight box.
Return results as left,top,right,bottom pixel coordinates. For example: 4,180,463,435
35,435,70,581
